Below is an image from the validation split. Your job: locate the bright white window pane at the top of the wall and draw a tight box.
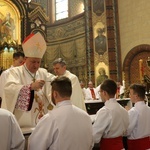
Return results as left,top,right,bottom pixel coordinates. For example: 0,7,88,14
55,0,68,20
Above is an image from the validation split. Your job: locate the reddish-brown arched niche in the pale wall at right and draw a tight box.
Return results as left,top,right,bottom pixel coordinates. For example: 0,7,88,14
123,44,150,88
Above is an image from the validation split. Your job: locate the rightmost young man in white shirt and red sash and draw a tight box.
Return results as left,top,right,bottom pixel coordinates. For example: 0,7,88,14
127,84,150,150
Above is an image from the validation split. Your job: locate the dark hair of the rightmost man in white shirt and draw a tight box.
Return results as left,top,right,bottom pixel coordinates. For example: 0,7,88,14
130,83,146,99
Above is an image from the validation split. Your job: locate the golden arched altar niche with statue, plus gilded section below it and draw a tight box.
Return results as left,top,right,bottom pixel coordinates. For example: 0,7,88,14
0,0,21,69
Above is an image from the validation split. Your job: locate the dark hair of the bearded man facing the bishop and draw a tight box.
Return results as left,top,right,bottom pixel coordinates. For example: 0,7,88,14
51,76,72,97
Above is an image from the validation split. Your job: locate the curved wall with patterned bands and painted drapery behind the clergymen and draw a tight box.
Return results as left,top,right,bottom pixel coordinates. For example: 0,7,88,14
44,15,87,81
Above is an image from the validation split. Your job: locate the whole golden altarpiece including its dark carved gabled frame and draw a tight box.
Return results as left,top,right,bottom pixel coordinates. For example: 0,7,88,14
0,0,49,69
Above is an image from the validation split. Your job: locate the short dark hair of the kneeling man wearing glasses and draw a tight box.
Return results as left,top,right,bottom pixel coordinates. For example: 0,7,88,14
100,79,117,96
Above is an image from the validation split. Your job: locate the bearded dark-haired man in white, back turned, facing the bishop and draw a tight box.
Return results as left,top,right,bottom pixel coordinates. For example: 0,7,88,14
28,76,93,150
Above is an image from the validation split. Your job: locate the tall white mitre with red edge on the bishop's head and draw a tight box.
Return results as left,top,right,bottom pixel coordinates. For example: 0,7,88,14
22,32,46,58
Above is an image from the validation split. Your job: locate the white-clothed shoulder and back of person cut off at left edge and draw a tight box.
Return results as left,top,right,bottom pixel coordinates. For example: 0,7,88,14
0,108,25,150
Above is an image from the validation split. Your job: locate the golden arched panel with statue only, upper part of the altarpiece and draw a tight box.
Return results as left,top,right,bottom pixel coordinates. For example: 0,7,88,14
0,0,20,42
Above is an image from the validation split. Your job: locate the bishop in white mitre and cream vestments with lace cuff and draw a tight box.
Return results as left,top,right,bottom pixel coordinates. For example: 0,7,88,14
2,32,54,130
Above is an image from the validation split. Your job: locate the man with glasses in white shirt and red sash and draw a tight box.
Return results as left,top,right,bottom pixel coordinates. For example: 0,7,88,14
93,79,129,150
